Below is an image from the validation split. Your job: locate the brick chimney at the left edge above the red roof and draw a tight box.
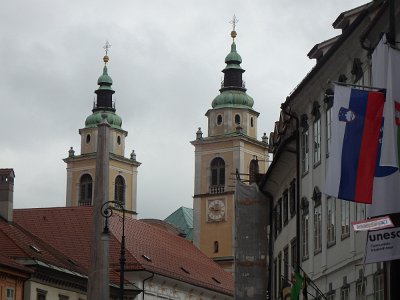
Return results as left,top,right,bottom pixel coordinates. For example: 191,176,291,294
0,169,15,222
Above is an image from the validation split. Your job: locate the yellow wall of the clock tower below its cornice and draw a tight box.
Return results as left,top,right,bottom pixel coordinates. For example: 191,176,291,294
194,137,268,264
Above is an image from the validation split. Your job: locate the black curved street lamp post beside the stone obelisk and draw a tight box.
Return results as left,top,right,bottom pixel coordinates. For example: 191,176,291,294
101,201,126,300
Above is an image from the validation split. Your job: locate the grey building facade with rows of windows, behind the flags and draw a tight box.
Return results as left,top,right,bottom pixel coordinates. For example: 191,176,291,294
261,1,400,300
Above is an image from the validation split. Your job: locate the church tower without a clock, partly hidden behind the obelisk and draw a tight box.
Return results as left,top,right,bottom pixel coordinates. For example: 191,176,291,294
64,51,140,217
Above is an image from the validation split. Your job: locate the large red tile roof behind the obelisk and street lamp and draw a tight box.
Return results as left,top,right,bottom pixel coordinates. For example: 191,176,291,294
14,206,233,295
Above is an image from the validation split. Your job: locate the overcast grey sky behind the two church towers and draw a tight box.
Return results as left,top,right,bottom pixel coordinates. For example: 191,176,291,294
0,0,366,219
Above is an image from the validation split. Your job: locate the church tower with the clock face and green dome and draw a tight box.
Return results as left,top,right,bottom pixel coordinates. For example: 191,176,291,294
191,25,268,272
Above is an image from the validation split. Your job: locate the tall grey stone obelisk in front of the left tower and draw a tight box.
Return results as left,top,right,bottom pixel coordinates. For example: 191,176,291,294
87,115,110,300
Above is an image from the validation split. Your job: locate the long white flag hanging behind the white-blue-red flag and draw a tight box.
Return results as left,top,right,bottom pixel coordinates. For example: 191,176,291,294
368,36,400,216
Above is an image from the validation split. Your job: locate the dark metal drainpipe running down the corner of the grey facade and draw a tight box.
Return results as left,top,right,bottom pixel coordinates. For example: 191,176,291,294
281,103,300,272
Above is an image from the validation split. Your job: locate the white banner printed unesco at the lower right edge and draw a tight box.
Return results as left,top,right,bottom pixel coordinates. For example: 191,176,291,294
365,227,400,264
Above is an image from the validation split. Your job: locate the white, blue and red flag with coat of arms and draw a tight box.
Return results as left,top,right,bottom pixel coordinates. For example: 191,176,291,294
325,85,385,203
